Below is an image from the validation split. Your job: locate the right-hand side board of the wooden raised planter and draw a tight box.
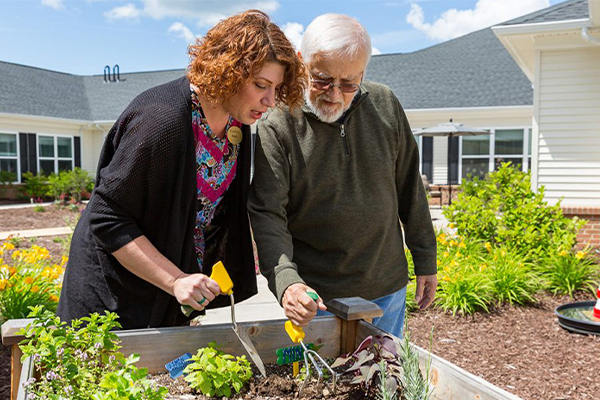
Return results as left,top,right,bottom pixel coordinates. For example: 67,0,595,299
356,321,521,400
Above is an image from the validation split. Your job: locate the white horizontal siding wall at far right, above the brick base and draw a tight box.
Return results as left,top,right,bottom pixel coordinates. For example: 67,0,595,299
533,47,600,207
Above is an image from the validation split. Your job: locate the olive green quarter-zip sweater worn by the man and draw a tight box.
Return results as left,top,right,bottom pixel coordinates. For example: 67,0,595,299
248,82,437,302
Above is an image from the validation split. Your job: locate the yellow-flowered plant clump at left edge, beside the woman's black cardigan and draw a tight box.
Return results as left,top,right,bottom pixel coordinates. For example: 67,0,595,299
0,240,67,323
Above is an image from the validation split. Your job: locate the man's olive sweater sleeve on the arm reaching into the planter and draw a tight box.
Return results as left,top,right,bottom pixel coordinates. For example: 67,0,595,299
248,120,304,304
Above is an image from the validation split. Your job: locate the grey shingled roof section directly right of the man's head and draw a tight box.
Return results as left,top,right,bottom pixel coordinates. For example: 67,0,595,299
367,28,533,110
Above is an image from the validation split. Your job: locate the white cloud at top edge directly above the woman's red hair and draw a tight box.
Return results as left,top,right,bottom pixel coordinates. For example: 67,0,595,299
141,0,279,27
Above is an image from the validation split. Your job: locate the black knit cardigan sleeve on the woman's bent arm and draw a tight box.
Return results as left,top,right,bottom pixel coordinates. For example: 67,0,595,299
87,102,185,253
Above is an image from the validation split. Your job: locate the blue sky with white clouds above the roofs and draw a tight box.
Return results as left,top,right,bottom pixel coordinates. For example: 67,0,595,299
0,0,563,75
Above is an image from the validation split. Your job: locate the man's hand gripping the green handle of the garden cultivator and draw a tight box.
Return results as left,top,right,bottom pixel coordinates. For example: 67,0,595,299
281,283,327,326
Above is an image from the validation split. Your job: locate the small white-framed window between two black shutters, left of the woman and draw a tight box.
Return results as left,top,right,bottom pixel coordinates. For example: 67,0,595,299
38,135,73,175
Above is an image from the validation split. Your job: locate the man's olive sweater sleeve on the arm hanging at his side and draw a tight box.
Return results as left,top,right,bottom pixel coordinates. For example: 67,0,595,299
394,96,437,275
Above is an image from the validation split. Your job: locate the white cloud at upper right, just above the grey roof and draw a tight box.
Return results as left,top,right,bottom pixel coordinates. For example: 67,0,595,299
406,0,550,40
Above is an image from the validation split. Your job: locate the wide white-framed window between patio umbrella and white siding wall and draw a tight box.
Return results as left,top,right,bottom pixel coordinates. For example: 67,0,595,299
460,128,531,179
